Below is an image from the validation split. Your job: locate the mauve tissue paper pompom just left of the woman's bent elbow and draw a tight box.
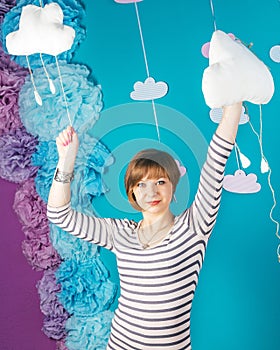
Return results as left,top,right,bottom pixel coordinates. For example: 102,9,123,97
13,179,48,230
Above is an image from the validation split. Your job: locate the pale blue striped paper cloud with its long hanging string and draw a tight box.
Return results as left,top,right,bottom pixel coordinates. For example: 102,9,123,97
114,0,168,142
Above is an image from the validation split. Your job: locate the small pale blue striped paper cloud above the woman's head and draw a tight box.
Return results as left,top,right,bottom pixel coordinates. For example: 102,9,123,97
130,77,168,101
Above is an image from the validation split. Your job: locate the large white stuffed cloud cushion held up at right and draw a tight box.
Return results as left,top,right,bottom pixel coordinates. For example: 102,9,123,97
202,30,274,108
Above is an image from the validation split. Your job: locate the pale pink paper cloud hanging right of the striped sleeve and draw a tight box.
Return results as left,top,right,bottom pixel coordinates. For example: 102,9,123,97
223,170,261,193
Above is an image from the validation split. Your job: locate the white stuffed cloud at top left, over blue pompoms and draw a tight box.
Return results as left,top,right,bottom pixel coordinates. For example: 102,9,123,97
6,3,75,56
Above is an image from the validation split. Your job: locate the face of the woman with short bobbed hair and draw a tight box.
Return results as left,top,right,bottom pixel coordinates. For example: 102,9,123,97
133,177,173,214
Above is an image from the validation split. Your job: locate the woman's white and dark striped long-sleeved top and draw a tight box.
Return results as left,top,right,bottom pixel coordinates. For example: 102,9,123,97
48,134,233,350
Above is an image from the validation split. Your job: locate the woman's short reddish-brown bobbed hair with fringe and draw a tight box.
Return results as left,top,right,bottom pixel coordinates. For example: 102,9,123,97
124,148,180,211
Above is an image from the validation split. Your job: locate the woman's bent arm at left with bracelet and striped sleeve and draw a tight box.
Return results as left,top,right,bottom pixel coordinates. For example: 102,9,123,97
47,126,116,250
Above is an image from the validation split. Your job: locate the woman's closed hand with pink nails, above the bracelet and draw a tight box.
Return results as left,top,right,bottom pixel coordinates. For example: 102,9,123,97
56,126,79,171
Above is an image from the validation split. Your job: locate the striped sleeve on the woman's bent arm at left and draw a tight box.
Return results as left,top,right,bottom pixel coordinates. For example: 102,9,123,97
47,203,116,250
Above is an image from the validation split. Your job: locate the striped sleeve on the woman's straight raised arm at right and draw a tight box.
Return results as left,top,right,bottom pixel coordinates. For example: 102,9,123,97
189,134,233,235
